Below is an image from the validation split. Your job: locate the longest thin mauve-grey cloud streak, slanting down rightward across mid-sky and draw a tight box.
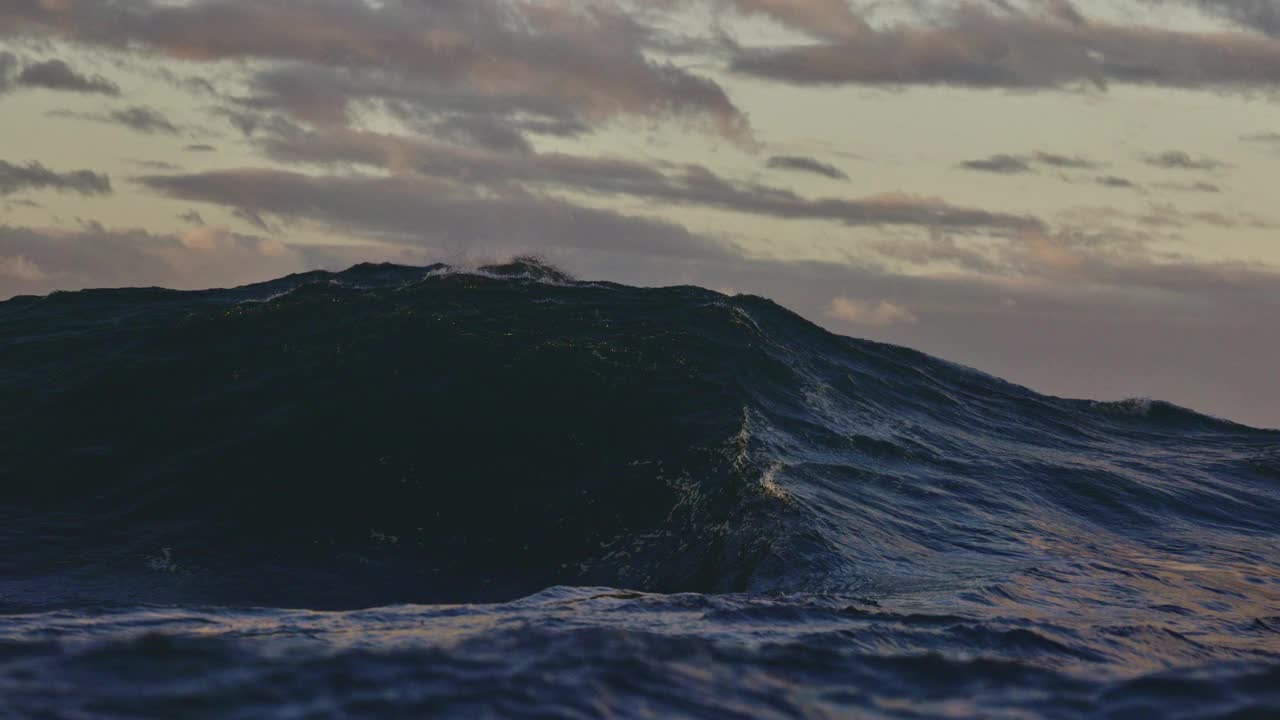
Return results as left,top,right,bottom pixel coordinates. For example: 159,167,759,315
254,131,1038,228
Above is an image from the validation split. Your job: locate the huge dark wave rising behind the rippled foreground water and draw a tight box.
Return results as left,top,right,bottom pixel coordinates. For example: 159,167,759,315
0,260,1280,607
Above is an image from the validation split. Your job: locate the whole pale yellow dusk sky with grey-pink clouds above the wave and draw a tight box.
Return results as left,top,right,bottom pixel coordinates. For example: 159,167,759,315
0,0,1280,428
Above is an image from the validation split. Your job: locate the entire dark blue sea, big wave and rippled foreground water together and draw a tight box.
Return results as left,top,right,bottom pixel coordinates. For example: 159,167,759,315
0,260,1280,719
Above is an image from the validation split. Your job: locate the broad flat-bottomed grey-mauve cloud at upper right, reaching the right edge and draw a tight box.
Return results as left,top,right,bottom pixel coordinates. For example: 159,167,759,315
732,1,1280,90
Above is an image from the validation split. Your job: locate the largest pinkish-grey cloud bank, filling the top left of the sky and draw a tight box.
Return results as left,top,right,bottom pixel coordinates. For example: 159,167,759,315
0,0,750,141
